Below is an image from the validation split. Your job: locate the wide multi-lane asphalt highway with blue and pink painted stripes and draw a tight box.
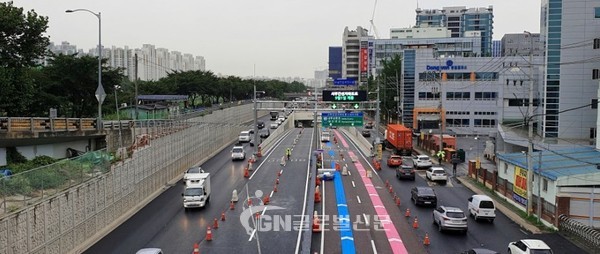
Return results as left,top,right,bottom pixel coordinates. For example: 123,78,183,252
86,115,582,253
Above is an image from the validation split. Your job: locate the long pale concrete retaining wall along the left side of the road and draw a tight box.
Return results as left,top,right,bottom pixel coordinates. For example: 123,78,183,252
0,105,266,254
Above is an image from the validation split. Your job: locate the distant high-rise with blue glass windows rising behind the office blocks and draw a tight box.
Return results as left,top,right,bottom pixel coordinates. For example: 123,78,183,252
416,6,494,56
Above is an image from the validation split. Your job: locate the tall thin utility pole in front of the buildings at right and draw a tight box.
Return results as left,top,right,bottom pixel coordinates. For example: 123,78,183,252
525,31,540,216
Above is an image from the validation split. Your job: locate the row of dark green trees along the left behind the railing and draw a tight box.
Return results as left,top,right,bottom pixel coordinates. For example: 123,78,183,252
0,2,306,117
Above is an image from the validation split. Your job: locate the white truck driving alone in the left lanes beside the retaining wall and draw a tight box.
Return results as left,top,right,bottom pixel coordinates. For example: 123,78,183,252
181,173,211,210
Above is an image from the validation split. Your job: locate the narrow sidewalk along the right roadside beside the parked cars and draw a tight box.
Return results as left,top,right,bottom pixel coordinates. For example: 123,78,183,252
413,147,542,234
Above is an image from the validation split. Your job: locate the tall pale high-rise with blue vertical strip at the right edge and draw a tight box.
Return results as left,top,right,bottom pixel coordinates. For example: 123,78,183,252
540,0,600,139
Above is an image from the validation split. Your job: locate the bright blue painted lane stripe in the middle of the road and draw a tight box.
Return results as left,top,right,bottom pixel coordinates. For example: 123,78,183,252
333,171,356,254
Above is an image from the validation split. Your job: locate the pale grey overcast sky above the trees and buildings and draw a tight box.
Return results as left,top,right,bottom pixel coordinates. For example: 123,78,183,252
14,0,540,78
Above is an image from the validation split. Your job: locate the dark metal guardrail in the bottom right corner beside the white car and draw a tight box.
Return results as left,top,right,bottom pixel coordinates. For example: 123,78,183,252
558,214,600,253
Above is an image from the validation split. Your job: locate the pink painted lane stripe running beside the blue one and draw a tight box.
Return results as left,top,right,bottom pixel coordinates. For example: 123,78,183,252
346,152,408,254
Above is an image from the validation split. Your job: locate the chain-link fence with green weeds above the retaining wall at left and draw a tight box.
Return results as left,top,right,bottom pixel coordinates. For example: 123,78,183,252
0,149,112,213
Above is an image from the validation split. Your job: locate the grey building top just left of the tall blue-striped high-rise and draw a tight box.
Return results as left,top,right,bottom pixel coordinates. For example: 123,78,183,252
502,33,544,56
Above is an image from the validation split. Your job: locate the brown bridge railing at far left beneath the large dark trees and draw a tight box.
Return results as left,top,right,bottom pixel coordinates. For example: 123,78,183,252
0,117,96,132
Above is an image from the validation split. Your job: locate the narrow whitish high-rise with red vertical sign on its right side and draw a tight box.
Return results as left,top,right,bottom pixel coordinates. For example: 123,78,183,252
342,26,369,82
